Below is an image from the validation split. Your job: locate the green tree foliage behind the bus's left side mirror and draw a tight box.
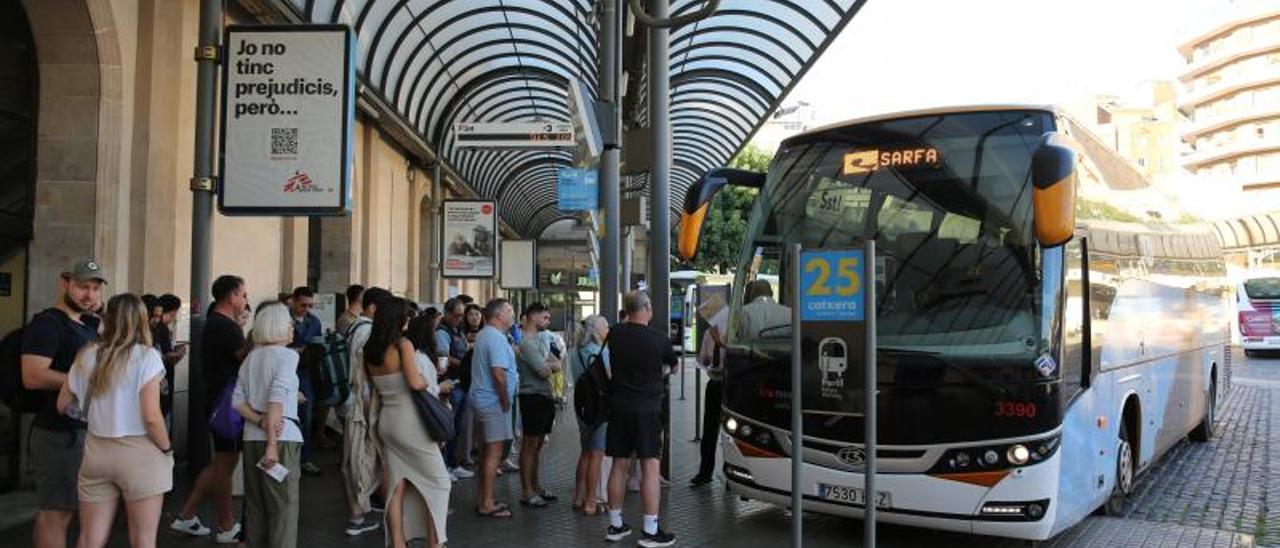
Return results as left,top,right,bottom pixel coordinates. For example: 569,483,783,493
671,145,773,273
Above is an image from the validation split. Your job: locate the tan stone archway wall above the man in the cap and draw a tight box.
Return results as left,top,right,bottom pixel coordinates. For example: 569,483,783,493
22,0,128,315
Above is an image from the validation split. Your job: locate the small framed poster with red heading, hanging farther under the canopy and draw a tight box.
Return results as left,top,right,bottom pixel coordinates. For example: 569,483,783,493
440,200,498,278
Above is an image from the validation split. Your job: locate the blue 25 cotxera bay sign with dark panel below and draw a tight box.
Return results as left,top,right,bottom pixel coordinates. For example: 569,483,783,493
800,250,867,416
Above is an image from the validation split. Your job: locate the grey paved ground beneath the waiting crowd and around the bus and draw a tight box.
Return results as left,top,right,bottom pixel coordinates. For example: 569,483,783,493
0,361,1280,548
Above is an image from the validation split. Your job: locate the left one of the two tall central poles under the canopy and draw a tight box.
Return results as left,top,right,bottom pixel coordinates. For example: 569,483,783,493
599,0,622,324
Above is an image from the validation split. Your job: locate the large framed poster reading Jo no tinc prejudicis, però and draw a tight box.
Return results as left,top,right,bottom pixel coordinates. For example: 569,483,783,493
218,24,356,216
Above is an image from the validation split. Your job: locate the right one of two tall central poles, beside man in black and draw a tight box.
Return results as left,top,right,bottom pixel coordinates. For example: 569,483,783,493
648,0,684,479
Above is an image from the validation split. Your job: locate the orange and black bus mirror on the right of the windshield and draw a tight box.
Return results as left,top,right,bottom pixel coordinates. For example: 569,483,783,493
1032,132,1075,247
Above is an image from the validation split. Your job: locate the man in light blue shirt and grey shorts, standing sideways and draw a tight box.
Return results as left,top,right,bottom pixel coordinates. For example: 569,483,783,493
467,298,520,517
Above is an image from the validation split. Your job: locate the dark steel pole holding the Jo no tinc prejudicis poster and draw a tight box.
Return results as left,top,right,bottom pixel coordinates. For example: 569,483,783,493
186,0,223,475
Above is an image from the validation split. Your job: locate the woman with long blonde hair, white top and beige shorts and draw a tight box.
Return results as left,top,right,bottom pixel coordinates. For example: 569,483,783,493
58,293,173,548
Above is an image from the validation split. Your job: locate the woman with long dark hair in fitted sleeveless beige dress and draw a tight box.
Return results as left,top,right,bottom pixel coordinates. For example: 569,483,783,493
365,298,451,548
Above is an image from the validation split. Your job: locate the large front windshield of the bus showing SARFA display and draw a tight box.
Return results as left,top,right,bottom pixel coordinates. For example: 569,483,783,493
730,110,1061,385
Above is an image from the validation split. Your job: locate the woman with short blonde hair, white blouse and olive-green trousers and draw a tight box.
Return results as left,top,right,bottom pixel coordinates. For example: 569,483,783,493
232,302,302,547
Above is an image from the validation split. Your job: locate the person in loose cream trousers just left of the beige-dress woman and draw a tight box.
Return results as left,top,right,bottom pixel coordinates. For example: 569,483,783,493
342,287,392,536
